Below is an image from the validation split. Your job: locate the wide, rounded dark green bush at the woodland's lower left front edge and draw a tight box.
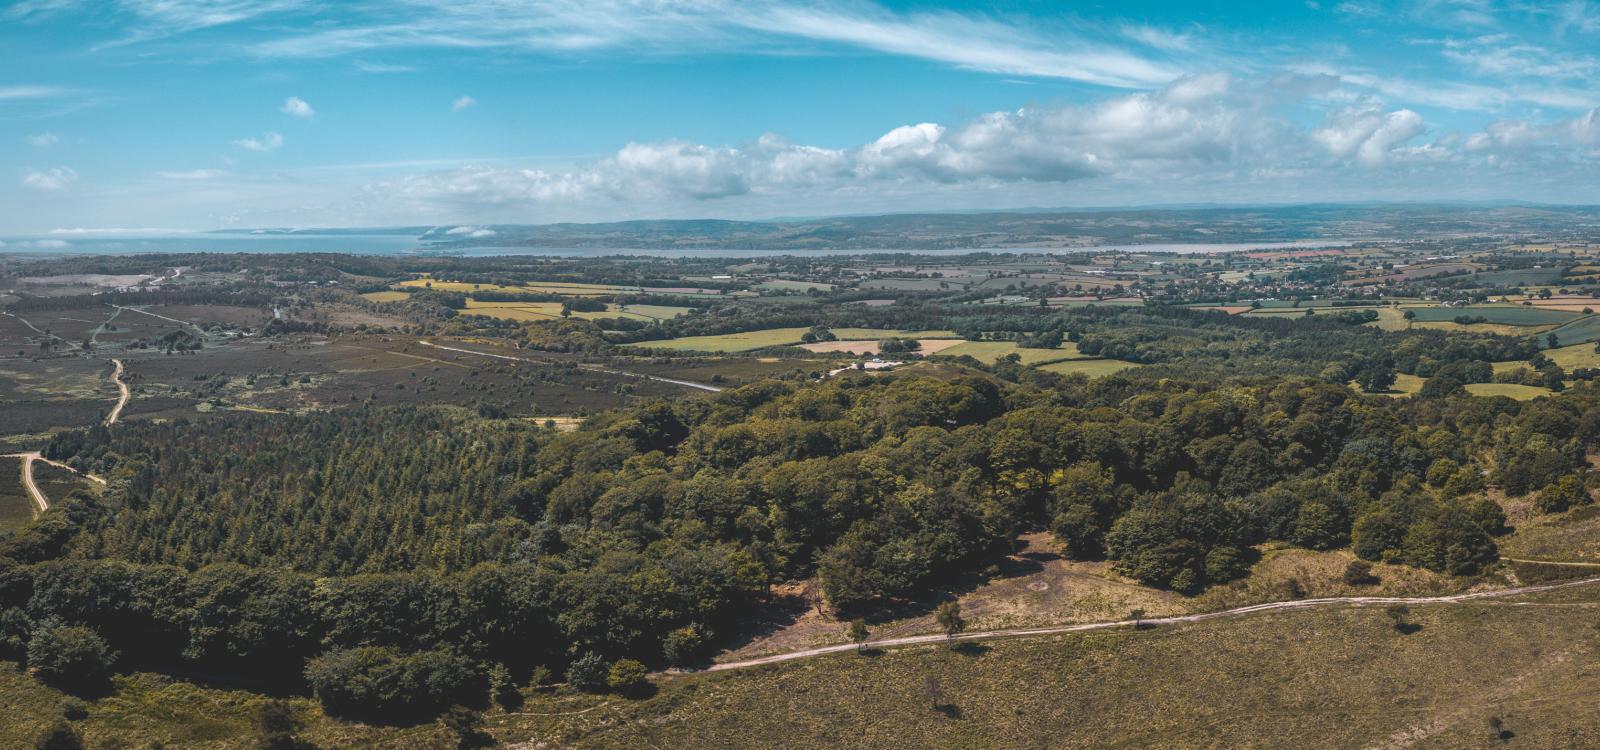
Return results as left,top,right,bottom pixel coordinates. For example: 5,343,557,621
306,646,486,720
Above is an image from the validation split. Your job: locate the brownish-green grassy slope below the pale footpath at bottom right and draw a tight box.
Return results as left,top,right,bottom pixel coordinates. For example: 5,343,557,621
528,590,1600,748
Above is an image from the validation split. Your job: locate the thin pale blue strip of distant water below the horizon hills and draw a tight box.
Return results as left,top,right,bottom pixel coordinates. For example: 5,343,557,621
0,232,1371,257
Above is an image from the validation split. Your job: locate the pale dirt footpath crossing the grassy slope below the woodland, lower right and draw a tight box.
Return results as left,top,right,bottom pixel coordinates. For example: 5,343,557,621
701,572,1600,672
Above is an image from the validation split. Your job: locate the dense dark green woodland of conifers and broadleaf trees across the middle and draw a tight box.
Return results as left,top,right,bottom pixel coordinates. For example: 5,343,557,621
0,348,1600,718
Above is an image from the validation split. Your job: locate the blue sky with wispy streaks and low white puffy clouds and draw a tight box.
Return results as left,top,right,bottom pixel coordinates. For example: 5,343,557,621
0,0,1600,235
